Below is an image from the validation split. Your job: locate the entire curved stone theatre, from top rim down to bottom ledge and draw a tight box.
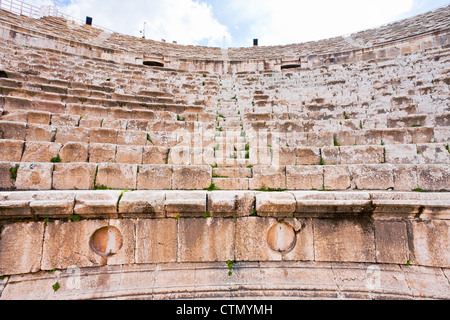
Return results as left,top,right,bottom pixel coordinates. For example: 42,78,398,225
0,6,450,299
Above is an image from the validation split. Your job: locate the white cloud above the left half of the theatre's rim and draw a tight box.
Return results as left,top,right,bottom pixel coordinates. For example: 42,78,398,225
51,0,231,46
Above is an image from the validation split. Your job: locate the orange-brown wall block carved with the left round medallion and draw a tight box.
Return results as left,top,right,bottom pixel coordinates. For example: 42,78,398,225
41,220,135,270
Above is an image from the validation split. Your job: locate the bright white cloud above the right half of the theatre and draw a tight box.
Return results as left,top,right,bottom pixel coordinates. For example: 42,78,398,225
230,0,414,45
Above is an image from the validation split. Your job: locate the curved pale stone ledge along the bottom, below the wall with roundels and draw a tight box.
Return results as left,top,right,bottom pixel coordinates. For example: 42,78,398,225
0,262,450,300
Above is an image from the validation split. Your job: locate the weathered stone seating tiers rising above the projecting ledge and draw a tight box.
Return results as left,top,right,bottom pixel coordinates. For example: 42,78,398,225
0,6,450,191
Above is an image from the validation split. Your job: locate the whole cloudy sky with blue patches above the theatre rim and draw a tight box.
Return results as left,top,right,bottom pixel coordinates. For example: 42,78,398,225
25,0,450,47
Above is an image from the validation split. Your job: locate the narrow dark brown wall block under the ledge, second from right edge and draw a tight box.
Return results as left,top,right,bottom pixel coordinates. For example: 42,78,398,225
374,221,409,264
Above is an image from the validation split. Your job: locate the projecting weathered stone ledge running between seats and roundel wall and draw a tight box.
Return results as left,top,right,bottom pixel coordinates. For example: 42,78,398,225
0,190,450,220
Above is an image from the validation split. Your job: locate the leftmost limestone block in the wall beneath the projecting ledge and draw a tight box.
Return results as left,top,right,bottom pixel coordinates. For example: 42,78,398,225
0,222,44,275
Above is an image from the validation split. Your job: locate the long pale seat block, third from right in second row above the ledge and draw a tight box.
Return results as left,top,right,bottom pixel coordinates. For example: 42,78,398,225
339,146,384,164
